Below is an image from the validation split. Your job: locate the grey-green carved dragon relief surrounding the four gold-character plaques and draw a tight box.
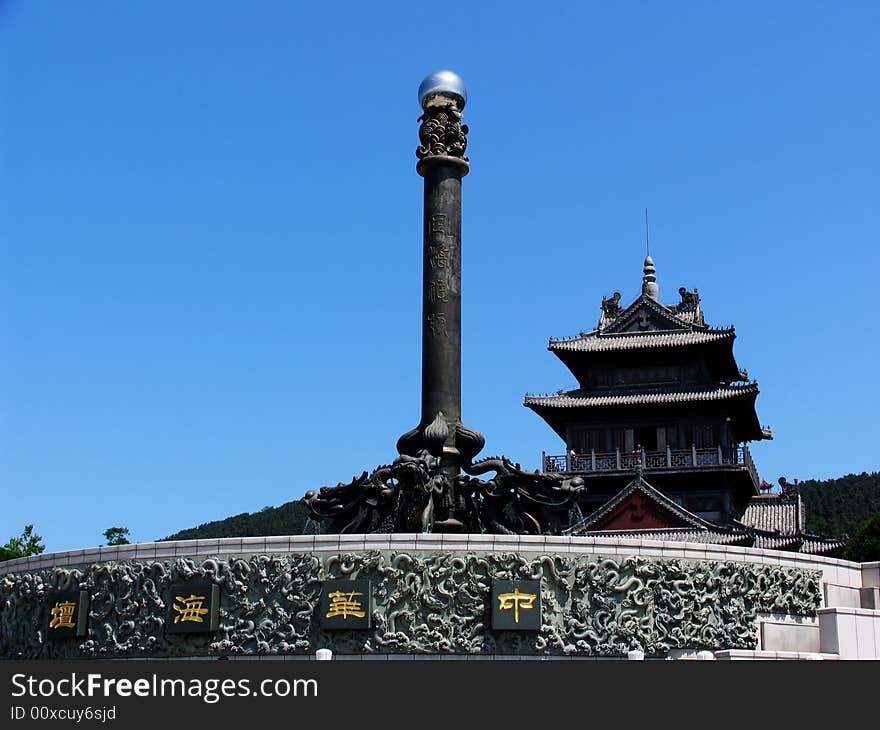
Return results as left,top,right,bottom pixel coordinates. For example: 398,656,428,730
0,552,821,658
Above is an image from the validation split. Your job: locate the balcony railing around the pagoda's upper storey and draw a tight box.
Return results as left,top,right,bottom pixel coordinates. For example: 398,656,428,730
543,445,759,487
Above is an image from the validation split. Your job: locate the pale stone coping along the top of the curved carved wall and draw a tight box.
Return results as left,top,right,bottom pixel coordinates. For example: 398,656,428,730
0,533,868,587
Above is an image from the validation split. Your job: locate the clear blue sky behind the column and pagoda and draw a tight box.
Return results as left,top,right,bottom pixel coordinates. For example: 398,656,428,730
0,0,880,550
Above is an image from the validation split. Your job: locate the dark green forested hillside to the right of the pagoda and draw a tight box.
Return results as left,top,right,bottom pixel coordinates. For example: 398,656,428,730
797,471,880,537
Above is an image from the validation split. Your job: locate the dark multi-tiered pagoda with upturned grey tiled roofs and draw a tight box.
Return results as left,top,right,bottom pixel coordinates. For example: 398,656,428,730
524,256,840,552
